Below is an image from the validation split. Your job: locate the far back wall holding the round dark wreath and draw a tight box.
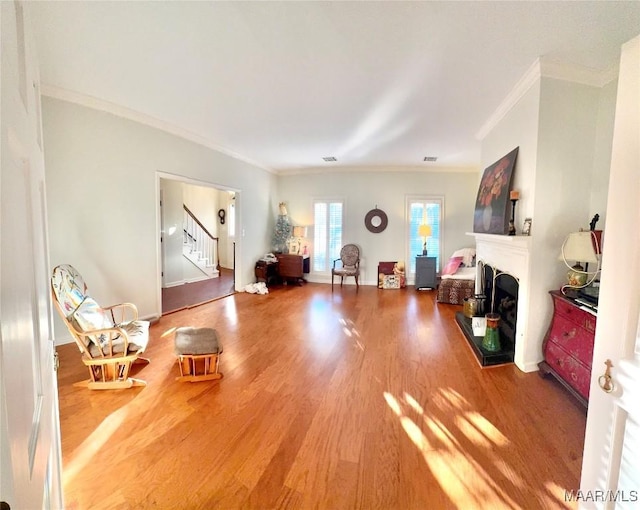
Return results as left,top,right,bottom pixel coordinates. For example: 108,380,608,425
272,168,478,285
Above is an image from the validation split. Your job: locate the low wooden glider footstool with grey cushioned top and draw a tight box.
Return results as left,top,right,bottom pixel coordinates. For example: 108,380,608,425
175,328,222,382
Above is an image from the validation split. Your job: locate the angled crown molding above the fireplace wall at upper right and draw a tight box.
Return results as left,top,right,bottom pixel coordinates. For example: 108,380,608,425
476,58,618,141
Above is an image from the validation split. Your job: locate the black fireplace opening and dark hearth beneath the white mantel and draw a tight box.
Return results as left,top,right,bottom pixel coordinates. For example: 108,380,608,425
456,262,519,367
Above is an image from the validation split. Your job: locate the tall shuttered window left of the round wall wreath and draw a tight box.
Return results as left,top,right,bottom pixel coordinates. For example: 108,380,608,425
313,200,343,272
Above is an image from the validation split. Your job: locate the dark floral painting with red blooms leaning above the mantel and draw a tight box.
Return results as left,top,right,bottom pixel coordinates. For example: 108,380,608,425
473,147,519,234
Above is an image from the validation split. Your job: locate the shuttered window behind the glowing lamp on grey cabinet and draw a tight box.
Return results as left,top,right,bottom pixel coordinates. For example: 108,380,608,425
407,197,444,274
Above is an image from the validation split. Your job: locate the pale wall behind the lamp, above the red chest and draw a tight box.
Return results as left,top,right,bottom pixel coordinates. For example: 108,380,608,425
532,78,604,288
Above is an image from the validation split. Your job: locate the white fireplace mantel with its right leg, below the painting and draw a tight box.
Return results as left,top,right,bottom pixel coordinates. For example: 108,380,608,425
467,232,538,372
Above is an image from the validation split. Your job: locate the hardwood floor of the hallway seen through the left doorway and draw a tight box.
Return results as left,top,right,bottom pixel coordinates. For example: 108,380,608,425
162,268,235,315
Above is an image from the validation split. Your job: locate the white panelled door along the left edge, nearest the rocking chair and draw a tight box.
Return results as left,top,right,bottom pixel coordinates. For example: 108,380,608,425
0,2,62,509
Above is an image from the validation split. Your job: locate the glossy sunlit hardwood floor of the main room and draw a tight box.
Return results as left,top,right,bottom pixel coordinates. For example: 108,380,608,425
58,284,586,510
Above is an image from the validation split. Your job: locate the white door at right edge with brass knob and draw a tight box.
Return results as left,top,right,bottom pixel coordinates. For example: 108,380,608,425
577,37,640,508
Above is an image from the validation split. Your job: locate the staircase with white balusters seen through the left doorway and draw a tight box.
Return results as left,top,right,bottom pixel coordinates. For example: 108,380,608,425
182,205,220,279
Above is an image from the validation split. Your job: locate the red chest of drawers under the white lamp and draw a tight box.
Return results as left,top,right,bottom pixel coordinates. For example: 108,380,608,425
538,291,597,407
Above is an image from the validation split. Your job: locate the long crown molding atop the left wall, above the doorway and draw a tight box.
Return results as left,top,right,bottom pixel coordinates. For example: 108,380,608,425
40,83,275,173
